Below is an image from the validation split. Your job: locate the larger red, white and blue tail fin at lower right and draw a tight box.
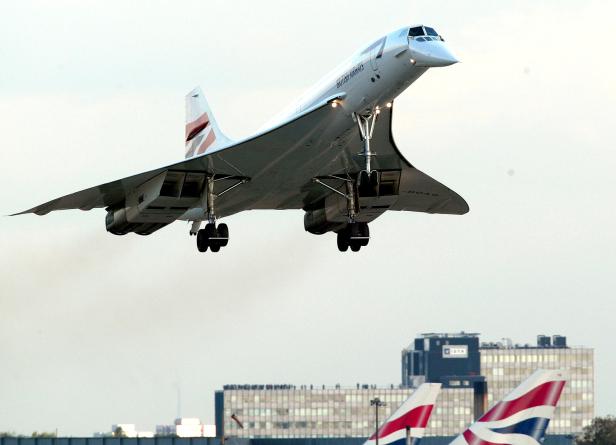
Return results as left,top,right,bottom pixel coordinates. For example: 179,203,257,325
450,369,566,445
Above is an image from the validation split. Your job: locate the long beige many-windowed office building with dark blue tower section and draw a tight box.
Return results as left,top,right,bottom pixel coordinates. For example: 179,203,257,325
215,332,594,439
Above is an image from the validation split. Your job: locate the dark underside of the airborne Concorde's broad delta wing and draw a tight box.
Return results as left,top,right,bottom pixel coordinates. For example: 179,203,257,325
16,98,469,222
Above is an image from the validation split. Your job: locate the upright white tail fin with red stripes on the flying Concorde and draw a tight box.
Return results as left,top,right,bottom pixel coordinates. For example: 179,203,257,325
185,87,230,158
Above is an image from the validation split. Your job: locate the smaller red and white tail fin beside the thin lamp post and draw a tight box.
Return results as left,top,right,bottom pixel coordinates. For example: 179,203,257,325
364,383,441,445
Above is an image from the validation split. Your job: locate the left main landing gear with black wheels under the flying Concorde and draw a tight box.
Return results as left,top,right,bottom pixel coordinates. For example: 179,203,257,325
190,176,248,252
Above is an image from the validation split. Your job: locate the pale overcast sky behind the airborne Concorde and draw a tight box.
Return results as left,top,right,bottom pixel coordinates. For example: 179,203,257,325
0,0,616,435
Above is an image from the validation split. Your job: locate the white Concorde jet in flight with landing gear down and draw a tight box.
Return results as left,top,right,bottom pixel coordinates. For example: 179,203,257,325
19,26,468,252
